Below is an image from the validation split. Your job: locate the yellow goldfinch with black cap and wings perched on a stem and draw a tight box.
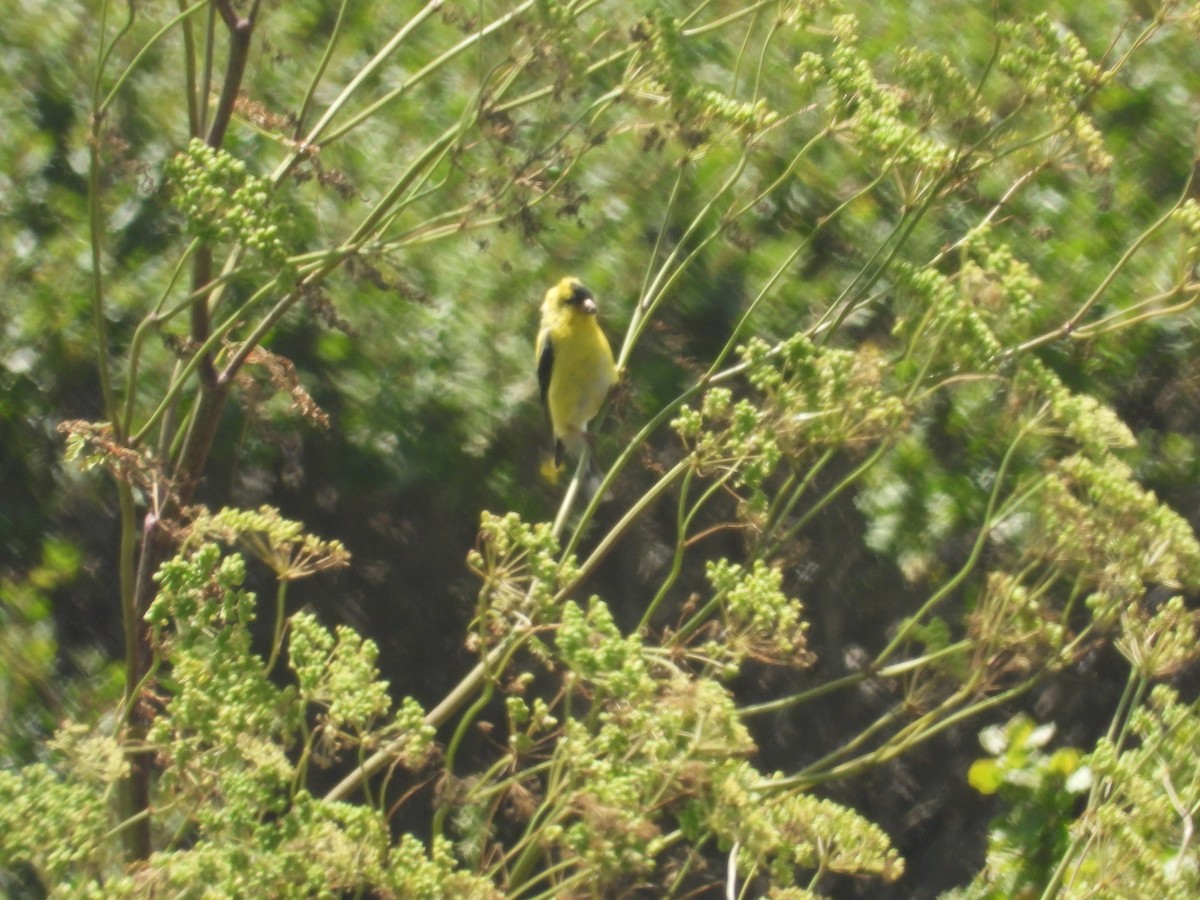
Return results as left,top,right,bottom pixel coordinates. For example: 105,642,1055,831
536,278,617,469
